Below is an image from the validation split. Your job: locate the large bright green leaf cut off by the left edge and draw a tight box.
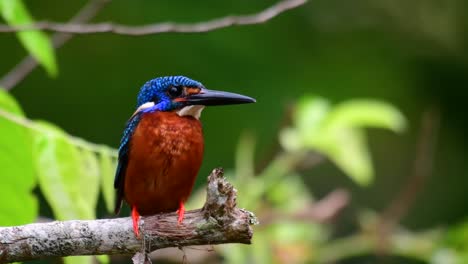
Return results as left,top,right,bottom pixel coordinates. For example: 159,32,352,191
0,90,38,226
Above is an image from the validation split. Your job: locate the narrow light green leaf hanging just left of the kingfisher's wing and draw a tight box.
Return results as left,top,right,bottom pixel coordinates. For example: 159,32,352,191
99,146,116,212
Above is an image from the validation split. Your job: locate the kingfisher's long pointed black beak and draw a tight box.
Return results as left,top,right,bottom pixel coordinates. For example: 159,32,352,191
186,88,256,105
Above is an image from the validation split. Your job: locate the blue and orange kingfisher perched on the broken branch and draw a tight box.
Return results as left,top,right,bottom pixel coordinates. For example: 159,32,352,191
114,76,255,237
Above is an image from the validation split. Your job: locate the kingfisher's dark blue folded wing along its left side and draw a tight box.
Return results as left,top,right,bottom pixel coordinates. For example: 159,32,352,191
114,112,142,214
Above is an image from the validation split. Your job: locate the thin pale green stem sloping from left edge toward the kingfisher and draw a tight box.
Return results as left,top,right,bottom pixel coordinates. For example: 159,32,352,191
0,109,117,158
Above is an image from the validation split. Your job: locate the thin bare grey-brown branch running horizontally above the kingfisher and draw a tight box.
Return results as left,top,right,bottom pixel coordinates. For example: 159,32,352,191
0,0,307,36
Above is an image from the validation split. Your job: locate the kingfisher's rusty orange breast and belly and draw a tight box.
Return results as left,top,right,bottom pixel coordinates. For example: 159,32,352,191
124,112,204,215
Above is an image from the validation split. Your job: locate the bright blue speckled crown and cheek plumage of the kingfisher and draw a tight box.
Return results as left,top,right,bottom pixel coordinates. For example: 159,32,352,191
137,76,203,111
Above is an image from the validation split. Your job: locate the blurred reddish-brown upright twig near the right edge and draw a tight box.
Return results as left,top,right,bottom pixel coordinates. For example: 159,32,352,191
378,110,440,252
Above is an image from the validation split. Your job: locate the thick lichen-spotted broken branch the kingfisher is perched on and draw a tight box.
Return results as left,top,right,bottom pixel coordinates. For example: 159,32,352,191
0,169,257,263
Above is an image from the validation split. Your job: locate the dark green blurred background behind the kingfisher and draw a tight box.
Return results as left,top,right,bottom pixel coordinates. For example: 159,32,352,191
0,0,468,263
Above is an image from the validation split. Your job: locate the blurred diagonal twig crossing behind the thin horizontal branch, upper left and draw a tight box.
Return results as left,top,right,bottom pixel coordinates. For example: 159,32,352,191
0,0,110,90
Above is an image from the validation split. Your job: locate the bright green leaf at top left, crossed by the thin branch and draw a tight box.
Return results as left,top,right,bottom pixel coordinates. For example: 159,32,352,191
0,0,58,76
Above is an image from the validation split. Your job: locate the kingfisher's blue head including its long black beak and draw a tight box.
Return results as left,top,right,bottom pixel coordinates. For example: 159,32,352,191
137,76,255,118
